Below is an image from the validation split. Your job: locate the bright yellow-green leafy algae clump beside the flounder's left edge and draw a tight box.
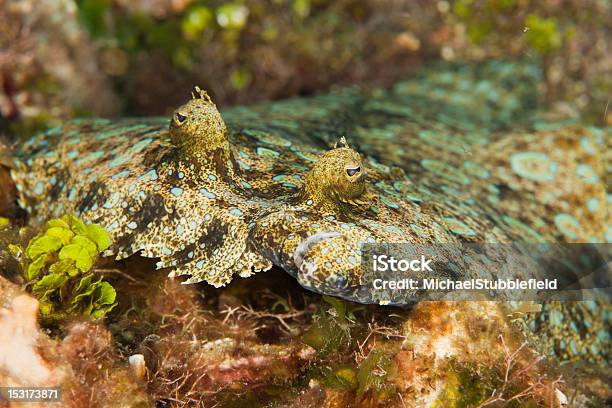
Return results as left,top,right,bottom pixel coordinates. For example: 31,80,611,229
9,215,116,325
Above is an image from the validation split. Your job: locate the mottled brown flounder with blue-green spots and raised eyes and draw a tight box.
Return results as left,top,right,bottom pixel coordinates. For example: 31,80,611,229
12,62,612,355
